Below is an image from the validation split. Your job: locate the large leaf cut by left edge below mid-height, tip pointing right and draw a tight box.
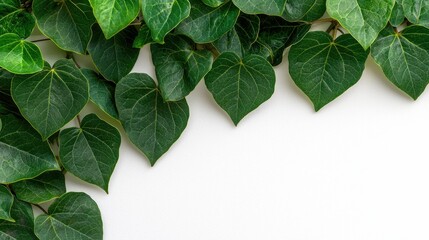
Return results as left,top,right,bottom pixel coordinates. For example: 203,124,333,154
0,115,60,184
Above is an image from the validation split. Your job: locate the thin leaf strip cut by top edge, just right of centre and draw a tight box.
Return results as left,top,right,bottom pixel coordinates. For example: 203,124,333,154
232,0,286,16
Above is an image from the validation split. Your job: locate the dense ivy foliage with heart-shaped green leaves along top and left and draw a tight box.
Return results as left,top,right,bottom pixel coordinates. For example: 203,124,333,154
0,0,429,237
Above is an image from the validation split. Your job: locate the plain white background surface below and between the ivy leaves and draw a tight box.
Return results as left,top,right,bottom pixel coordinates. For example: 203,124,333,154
39,38,429,240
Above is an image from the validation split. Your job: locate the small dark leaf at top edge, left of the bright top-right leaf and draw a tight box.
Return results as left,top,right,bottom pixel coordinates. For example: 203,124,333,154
283,0,326,22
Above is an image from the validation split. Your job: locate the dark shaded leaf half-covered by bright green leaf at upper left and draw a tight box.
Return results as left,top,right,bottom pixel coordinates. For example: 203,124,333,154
88,25,140,82
